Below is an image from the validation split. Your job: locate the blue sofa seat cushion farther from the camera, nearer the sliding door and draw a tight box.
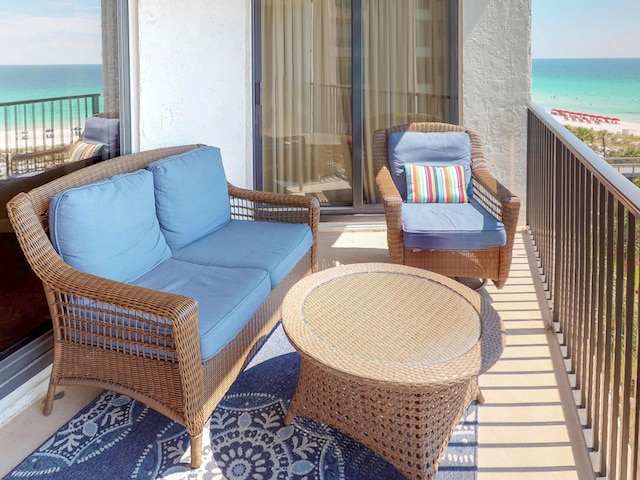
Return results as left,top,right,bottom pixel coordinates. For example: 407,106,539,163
173,220,313,287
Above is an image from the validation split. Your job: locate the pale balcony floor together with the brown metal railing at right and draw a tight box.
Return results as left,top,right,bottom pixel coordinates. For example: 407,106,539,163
0,107,640,480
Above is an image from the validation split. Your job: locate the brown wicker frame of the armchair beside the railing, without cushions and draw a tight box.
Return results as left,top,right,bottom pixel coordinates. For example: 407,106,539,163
373,122,520,288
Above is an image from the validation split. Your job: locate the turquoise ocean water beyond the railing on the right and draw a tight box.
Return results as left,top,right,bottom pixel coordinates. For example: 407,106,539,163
531,58,640,123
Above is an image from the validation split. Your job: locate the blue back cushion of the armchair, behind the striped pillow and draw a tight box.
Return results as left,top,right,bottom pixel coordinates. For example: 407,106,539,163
387,132,473,200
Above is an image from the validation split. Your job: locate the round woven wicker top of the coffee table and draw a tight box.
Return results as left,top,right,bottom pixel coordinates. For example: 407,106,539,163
282,263,504,384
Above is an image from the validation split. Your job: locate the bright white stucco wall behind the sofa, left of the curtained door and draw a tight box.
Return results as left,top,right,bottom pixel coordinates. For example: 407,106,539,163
130,0,252,186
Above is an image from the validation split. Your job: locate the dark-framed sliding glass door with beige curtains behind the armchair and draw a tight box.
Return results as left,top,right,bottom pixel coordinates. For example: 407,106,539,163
254,0,458,212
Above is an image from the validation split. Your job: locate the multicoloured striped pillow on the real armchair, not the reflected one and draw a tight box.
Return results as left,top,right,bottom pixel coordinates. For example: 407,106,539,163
404,163,469,203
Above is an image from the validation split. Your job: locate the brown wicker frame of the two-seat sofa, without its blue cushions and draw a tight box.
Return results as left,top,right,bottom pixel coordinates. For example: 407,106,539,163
7,145,320,467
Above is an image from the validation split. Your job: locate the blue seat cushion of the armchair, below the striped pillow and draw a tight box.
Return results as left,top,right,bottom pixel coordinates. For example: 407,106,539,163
402,199,507,250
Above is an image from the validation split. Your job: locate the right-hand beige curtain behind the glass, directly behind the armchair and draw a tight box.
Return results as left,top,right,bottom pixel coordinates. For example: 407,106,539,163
363,0,448,203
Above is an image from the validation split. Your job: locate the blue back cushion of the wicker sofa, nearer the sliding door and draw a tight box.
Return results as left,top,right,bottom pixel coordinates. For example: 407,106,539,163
147,147,231,251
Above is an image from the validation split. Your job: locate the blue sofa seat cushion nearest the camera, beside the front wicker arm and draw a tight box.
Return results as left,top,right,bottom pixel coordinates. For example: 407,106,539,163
133,259,271,362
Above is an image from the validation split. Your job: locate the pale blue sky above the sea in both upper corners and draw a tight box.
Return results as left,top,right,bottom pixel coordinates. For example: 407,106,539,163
0,0,640,65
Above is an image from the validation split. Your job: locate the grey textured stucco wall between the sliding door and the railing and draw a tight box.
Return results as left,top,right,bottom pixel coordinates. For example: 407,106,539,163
461,0,531,224
